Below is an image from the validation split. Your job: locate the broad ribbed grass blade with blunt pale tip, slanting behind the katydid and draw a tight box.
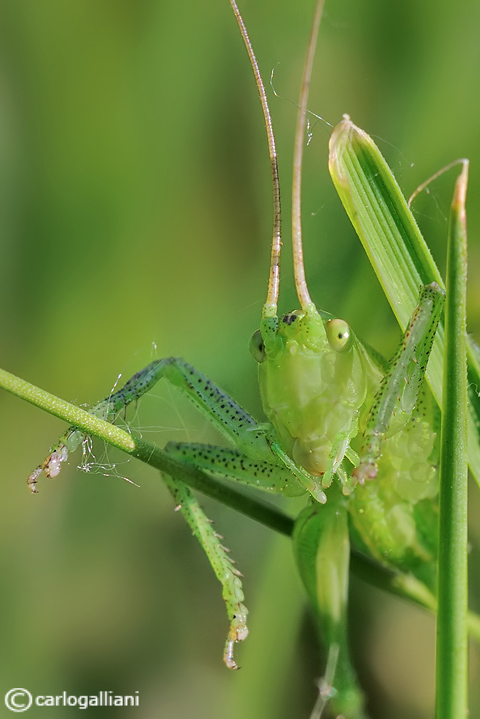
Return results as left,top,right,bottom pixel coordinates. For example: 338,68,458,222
329,117,480,484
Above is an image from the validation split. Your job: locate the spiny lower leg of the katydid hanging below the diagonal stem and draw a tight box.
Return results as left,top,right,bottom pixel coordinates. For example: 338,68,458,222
162,474,248,669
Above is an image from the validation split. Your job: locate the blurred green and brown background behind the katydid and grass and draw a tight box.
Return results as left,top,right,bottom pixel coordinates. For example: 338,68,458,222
0,0,480,719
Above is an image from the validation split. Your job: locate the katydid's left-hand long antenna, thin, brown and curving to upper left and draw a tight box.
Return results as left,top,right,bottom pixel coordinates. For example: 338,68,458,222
230,0,282,318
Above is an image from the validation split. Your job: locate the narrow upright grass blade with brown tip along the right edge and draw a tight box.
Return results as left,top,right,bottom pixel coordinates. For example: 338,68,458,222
436,163,468,719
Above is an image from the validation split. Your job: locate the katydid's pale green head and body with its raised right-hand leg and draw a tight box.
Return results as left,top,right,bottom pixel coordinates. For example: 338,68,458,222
252,286,443,584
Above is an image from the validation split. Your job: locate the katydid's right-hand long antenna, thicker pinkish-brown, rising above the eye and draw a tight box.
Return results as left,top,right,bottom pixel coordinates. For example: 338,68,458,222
292,0,325,310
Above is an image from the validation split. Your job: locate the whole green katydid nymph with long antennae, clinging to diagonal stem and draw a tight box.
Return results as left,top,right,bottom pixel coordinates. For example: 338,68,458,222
28,0,464,719
